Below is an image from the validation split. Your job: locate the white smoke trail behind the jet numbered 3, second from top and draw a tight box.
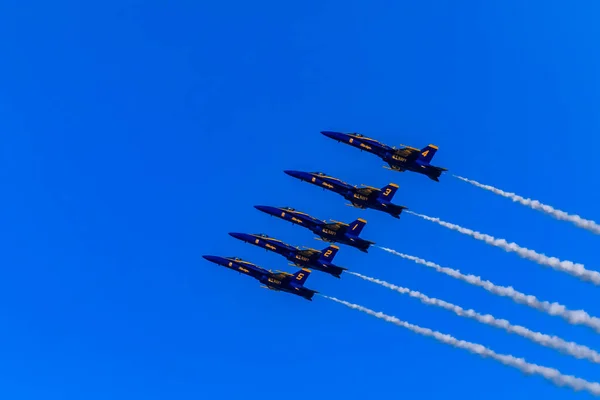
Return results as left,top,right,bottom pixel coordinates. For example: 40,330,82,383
405,211,600,285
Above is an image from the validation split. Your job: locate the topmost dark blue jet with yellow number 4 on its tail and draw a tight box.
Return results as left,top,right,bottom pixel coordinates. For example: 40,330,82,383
321,131,448,182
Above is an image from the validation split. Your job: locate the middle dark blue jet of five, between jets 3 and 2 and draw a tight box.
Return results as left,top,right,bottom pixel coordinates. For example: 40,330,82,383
254,206,375,253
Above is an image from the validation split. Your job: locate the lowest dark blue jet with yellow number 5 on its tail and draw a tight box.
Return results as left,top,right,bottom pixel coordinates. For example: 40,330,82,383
202,256,319,301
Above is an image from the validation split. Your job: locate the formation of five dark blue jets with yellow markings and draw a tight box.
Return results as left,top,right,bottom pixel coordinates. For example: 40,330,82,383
203,131,447,301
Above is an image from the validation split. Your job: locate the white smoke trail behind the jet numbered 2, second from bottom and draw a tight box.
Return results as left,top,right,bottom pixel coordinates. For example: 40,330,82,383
347,271,600,364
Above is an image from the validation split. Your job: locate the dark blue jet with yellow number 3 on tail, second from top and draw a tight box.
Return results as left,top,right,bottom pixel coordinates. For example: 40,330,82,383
284,170,408,218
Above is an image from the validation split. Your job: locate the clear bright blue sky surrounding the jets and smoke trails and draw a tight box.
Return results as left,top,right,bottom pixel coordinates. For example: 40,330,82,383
0,0,600,400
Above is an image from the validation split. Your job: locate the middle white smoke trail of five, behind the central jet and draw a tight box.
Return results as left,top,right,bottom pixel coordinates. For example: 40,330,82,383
379,247,600,333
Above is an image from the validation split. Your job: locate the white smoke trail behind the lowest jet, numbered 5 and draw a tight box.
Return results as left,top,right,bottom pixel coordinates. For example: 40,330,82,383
323,296,600,396
